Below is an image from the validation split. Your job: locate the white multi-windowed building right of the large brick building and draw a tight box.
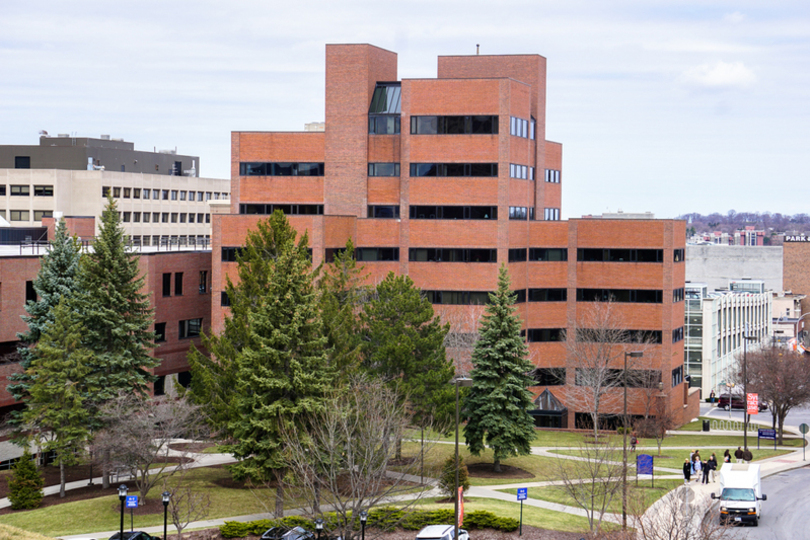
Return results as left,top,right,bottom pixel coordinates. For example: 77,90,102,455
684,279,773,398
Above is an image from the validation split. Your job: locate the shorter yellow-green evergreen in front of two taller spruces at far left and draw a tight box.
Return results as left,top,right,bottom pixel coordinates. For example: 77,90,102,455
23,299,92,497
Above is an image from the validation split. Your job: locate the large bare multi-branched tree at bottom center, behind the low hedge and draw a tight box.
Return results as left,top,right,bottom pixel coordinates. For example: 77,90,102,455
283,378,430,539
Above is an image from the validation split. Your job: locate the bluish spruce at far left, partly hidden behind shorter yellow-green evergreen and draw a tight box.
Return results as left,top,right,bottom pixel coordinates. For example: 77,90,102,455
6,220,81,404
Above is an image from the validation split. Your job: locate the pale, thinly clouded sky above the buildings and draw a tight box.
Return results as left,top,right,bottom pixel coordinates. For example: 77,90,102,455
0,0,810,218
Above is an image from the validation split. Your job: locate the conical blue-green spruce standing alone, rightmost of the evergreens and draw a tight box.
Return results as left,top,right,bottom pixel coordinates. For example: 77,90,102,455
464,265,534,472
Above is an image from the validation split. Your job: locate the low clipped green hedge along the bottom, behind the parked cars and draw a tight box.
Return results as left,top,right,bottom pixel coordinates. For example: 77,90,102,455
219,507,520,538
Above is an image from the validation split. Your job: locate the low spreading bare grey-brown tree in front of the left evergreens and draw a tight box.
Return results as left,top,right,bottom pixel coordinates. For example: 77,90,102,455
94,393,205,499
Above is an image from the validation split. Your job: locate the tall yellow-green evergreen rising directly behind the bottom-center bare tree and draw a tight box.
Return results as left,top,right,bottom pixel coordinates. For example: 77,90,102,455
228,227,333,517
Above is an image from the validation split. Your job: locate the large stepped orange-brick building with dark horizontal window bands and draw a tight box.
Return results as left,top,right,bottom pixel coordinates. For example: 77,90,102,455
211,45,698,427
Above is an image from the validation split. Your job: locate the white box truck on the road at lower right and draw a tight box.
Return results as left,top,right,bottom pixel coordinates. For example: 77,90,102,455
712,463,768,527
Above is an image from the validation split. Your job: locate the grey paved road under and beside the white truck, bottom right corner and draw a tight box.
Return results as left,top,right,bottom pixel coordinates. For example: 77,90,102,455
734,467,810,540
